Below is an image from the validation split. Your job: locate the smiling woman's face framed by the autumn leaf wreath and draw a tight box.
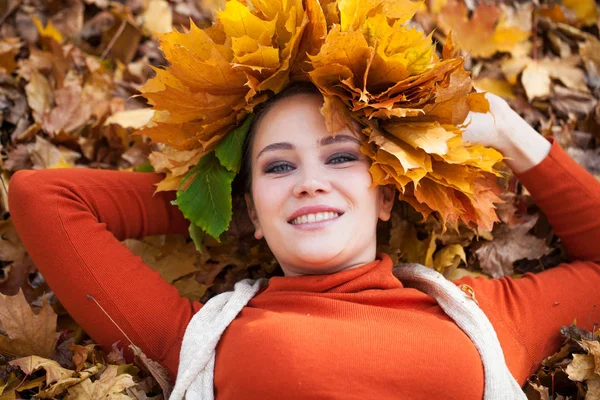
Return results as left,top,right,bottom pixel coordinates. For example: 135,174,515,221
247,94,395,276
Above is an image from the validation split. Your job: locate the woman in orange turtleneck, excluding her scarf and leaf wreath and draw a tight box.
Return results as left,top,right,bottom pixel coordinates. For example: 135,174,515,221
9,83,600,399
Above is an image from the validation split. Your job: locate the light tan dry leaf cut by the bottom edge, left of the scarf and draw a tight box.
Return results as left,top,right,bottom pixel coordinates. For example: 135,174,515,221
67,365,135,400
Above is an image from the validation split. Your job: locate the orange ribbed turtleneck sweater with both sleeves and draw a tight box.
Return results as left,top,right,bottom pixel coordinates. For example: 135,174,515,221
9,138,600,399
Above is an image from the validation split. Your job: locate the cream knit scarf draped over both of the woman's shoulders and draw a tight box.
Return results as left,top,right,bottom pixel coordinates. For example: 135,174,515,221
169,264,527,400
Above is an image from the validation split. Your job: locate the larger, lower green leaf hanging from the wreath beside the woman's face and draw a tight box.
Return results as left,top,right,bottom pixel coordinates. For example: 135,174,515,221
177,152,235,238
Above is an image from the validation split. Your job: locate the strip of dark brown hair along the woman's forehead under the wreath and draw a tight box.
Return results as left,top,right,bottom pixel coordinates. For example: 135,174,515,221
239,82,321,194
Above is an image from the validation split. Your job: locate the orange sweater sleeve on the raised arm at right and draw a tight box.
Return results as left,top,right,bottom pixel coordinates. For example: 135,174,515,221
454,137,600,384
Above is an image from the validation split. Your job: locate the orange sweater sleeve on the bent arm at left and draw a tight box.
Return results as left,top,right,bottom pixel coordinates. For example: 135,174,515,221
8,168,202,378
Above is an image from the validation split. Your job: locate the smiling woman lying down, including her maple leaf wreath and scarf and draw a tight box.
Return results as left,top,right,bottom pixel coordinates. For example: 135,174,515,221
9,0,600,400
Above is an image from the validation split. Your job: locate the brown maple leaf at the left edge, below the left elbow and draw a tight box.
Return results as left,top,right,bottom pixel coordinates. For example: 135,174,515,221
0,291,60,358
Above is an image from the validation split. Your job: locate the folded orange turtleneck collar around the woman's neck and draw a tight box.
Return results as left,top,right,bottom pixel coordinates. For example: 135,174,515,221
263,253,403,293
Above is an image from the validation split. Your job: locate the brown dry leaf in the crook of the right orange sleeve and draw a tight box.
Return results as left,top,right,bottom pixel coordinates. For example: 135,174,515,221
475,214,552,278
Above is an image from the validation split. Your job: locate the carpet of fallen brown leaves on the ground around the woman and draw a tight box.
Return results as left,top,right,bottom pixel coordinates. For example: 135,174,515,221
0,0,600,399
